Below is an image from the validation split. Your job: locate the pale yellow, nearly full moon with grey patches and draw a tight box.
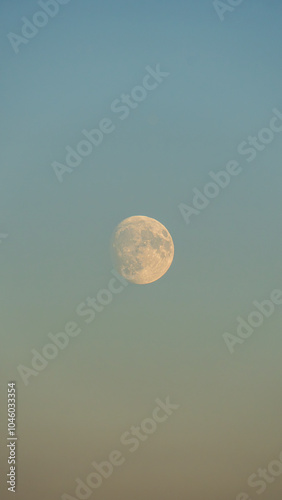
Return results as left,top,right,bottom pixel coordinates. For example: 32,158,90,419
111,215,174,285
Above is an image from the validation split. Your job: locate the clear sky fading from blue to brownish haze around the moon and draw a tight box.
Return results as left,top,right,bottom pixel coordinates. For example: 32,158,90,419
0,0,282,500
